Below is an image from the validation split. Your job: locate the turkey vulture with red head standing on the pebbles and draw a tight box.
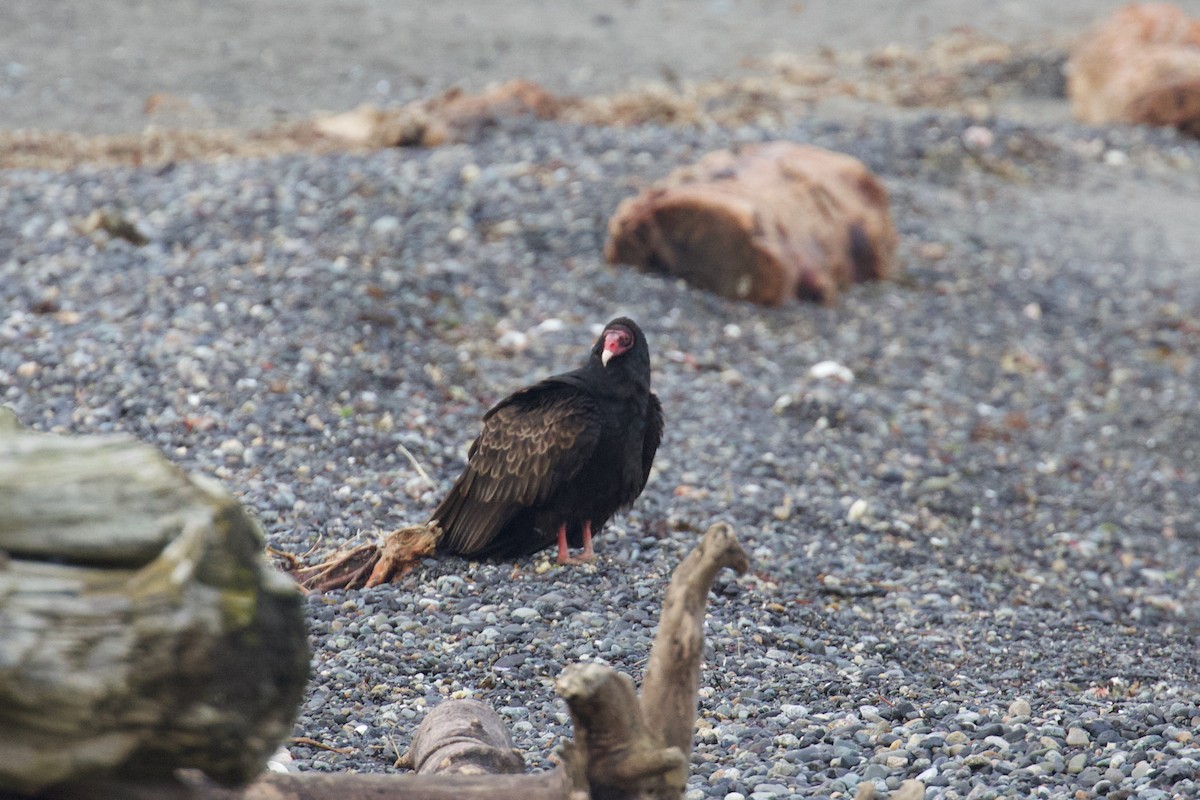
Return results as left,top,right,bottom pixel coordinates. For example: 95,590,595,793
431,317,662,564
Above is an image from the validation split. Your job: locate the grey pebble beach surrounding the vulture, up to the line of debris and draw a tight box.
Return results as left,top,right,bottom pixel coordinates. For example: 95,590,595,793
7,3,1200,800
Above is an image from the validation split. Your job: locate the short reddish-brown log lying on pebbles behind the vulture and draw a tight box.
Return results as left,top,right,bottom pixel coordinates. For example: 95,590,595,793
605,142,896,306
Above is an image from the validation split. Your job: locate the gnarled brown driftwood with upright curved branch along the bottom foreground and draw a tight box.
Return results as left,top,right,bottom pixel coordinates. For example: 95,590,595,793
72,523,748,800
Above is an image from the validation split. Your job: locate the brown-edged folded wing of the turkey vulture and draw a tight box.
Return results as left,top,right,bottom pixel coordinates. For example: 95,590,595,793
433,380,600,555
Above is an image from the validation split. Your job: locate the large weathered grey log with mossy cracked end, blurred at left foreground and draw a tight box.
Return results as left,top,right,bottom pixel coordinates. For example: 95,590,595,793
0,417,308,794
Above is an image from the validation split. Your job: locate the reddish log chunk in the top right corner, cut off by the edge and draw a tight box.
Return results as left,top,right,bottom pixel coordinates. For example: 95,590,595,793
1067,4,1200,136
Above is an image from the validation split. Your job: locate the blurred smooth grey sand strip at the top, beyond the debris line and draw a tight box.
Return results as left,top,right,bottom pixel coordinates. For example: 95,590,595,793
9,0,1200,134
